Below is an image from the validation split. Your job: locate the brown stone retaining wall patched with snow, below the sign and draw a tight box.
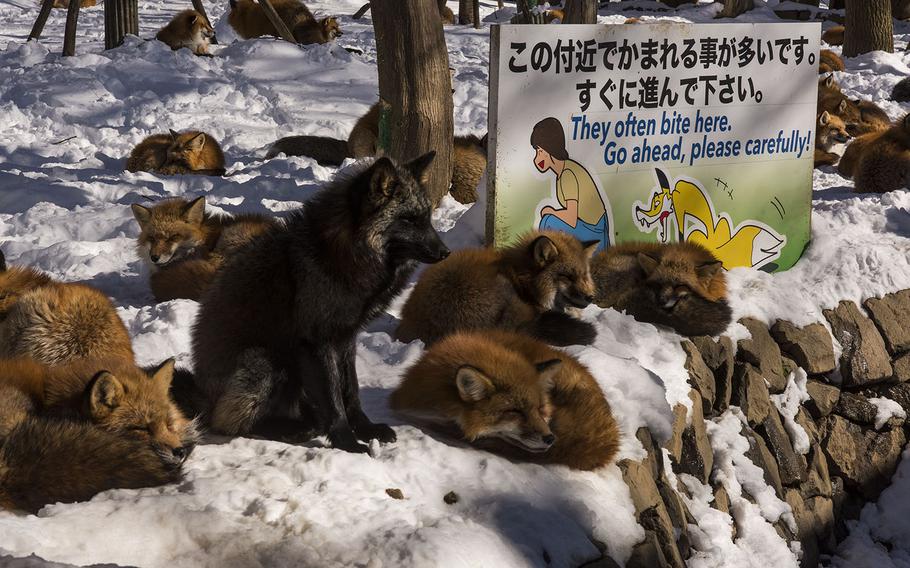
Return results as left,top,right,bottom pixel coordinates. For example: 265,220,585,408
591,290,910,568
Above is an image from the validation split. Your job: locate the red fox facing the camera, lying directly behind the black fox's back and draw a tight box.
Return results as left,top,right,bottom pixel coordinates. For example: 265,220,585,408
131,197,277,302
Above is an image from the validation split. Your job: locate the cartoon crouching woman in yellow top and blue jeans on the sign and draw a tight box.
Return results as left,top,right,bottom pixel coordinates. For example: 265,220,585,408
531,117,610,250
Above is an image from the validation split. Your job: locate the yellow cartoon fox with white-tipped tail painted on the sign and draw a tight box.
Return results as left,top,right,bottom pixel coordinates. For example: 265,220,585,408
635,169,786,270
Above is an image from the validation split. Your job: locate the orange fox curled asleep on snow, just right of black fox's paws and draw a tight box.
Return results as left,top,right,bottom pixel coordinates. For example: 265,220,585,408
389,331,620,470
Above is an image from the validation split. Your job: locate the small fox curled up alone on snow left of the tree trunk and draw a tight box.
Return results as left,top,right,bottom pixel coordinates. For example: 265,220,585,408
126,130,225,176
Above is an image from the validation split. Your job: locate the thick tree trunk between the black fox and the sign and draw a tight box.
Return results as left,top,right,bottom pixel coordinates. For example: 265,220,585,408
371,0,454,205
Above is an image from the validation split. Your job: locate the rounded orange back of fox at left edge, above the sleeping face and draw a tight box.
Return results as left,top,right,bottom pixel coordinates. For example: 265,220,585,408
0,260,133,365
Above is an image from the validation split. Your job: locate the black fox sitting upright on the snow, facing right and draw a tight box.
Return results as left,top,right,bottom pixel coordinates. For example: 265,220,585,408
193,152,449,452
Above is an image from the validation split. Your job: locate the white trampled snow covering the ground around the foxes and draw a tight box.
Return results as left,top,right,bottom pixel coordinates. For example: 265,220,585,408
0,0,910,568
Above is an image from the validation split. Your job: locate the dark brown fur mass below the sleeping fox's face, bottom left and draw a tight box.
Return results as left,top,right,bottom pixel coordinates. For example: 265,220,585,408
0,416,185,513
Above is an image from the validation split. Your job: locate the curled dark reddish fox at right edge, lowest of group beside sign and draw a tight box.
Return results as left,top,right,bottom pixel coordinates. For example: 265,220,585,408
853,114,910,193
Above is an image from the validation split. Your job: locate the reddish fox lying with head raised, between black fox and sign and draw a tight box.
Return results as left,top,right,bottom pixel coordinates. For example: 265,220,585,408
397,231,597,345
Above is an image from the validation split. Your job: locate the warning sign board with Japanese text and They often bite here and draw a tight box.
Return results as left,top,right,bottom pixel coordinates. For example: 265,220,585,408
487,23,821,271
